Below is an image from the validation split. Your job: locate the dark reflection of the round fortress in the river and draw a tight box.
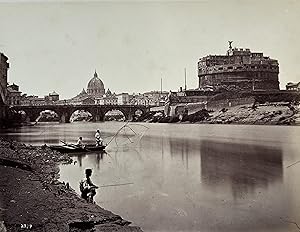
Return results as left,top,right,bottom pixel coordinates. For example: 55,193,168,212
200,140,283,199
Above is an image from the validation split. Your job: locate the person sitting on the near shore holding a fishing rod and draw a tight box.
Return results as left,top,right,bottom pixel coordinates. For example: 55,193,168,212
79,168,98,203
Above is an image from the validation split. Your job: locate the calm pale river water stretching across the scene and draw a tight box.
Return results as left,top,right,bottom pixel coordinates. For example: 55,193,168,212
0,122,300,232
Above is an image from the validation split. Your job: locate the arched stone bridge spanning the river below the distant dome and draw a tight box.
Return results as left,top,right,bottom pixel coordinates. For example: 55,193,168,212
10,104,150,123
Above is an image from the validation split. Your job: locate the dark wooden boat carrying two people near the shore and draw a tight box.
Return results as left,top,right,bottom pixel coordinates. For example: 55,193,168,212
49,144,106,153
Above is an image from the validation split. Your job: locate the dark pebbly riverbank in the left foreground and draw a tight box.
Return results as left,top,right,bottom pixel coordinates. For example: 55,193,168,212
0,139,141,232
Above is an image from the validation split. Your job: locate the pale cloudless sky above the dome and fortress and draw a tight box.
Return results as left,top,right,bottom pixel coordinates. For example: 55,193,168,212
0,0,300,99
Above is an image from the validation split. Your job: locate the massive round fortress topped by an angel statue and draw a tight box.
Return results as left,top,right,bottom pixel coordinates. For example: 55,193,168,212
198,41,279,91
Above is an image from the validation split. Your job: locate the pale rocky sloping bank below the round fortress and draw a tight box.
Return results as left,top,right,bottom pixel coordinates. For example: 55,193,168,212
142,102,300,125
